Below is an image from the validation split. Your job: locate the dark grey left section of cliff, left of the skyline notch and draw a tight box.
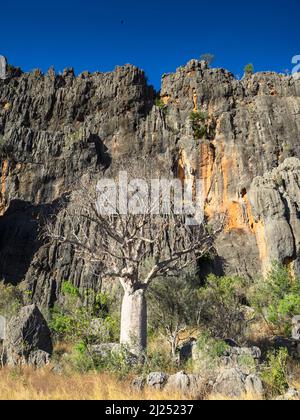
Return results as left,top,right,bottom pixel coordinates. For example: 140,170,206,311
0,66,157,305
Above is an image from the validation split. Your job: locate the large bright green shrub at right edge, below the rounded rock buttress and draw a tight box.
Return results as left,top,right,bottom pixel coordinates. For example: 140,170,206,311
249,263,300,337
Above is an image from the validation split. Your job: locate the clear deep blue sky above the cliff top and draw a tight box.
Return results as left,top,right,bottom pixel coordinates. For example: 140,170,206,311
0,0,300,88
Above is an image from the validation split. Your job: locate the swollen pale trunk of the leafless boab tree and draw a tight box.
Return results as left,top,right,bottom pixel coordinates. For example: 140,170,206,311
120,288,147,354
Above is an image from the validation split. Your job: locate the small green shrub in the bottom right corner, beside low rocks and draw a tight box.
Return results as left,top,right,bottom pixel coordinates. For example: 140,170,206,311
262,349,289,395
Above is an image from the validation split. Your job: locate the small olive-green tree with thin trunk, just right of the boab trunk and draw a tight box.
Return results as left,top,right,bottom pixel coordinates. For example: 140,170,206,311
149,273,200,358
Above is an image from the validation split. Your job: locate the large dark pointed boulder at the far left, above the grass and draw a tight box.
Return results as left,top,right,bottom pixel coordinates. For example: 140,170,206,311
4,305,53,367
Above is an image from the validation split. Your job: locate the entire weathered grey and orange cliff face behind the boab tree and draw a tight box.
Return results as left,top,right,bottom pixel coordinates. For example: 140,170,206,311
0,61,300,305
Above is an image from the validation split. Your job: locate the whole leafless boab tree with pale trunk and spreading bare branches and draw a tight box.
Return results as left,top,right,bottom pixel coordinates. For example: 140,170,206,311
47,175,219,353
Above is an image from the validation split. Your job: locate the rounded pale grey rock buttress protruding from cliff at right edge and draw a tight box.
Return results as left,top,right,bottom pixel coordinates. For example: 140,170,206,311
250,158,300,273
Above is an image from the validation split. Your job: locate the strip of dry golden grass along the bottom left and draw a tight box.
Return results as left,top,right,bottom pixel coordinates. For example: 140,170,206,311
0,367,181,400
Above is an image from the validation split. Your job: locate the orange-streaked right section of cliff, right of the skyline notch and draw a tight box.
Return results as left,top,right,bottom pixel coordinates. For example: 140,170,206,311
162,61,300,276
